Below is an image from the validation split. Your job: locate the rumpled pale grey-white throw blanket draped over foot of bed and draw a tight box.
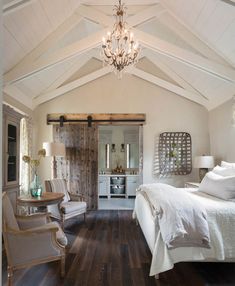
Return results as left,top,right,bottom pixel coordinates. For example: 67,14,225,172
139,184,210,249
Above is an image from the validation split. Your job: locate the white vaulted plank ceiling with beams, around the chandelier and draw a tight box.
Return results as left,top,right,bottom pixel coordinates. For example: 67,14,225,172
3,0,235,110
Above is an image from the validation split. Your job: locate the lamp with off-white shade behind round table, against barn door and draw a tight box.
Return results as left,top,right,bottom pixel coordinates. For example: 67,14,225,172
43,142,65,179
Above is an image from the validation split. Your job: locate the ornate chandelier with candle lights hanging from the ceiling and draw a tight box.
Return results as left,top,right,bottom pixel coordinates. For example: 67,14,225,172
102,0,140,78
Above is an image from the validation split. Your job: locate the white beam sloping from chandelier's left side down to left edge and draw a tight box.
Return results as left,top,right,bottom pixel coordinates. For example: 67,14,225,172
4,29,107,84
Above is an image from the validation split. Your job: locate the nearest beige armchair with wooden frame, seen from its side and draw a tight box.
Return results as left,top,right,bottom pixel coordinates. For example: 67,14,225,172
2,193,67,286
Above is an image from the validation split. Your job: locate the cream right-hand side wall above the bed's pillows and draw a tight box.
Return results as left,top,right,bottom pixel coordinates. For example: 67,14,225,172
209,100,235,163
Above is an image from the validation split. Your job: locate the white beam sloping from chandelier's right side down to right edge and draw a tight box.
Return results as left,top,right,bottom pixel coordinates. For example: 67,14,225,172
133,29,235,83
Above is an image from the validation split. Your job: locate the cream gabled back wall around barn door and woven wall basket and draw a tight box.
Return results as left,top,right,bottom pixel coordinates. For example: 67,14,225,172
34,74,209,186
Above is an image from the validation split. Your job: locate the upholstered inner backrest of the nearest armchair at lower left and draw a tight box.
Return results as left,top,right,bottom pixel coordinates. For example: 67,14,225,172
2,193,19,230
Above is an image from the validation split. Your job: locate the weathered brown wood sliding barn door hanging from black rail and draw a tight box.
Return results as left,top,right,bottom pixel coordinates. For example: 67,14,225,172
53,124,98,210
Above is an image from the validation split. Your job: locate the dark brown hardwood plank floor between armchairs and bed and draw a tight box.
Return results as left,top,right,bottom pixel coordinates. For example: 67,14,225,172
2,210,235,286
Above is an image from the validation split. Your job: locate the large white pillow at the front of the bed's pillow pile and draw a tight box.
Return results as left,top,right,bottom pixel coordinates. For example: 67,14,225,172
199,172,235,200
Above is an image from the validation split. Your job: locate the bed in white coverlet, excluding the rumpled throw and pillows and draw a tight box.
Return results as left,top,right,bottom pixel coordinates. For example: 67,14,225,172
133,185,235,276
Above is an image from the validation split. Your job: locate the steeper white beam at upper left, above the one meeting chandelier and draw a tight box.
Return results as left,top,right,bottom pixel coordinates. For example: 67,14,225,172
4,8,82,82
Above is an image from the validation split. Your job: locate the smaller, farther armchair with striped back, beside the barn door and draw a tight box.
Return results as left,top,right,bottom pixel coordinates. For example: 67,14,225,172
45,179,87,229
